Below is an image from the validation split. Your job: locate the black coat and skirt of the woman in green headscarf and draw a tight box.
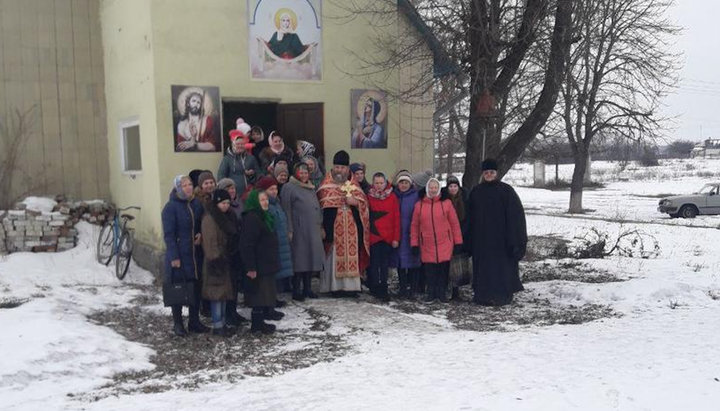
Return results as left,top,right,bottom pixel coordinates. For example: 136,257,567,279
240,211,280,307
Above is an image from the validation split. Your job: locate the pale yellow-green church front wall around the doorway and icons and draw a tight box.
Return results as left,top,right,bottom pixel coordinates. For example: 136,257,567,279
102,0,433,256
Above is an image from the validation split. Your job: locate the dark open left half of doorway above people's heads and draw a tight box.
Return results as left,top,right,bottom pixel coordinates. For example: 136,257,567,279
223,100,278,150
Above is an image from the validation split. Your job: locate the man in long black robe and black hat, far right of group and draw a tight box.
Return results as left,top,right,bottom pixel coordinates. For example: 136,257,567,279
466,159,527,305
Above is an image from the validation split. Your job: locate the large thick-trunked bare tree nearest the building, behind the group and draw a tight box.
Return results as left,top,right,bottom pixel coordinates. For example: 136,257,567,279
336,0,579,186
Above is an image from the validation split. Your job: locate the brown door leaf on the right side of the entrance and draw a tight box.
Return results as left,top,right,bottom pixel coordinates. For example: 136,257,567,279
277,103,325,164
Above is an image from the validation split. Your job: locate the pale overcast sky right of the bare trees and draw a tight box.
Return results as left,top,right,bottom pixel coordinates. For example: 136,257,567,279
665,0,720,141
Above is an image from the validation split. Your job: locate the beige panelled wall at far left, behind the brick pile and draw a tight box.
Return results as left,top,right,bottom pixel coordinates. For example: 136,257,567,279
0,0,108,205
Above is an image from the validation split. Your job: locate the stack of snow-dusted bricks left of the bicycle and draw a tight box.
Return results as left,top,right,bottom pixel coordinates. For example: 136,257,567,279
2,210,77,253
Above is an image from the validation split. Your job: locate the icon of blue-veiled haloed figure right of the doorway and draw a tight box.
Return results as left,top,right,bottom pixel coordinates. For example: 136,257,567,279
350,90,387,148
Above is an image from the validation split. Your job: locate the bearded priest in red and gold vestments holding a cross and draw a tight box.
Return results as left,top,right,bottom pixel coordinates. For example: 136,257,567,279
318,150,370,294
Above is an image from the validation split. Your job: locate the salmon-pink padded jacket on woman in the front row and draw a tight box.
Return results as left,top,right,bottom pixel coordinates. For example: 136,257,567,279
410,190,462,263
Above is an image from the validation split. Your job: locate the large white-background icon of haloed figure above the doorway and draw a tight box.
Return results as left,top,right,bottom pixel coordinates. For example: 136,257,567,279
248,0,322,81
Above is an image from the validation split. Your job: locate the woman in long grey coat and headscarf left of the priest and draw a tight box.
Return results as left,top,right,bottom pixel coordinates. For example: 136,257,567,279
280,163,325,301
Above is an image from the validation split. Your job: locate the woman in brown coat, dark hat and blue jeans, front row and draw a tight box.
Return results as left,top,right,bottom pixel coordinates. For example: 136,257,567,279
202,189,237,336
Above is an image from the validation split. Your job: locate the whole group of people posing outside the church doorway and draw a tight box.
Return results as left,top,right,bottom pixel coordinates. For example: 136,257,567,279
162,120,527,336
